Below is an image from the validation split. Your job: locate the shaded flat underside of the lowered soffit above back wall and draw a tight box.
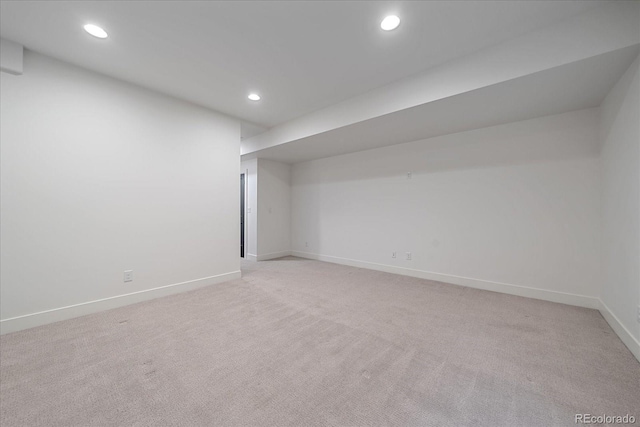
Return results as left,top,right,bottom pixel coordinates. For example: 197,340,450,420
248,45,640,163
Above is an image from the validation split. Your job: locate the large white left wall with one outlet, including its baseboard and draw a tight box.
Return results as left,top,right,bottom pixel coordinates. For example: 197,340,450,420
0,52,240,332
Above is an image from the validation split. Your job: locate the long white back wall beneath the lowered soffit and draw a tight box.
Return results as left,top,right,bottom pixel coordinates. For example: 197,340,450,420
291,109,601,308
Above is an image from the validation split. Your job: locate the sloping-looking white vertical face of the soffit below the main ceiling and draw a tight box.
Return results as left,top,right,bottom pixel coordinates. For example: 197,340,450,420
241,1,640,155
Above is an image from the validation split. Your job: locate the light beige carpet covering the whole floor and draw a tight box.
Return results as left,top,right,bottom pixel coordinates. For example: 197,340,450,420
0,258,640,427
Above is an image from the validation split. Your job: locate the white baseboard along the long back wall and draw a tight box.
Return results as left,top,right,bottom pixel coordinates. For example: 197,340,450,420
291,251,600,310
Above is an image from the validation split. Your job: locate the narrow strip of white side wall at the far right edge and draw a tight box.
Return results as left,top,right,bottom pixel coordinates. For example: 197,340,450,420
600,54,640,348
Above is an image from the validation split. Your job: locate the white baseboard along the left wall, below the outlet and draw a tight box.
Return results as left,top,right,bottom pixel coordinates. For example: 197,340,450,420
0,271,241,335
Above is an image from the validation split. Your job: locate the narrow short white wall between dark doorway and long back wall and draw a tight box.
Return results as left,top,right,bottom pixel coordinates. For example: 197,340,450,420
257,159,291,260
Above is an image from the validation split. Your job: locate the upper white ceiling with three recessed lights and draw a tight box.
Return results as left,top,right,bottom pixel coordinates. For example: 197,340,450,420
0,0,604,132
